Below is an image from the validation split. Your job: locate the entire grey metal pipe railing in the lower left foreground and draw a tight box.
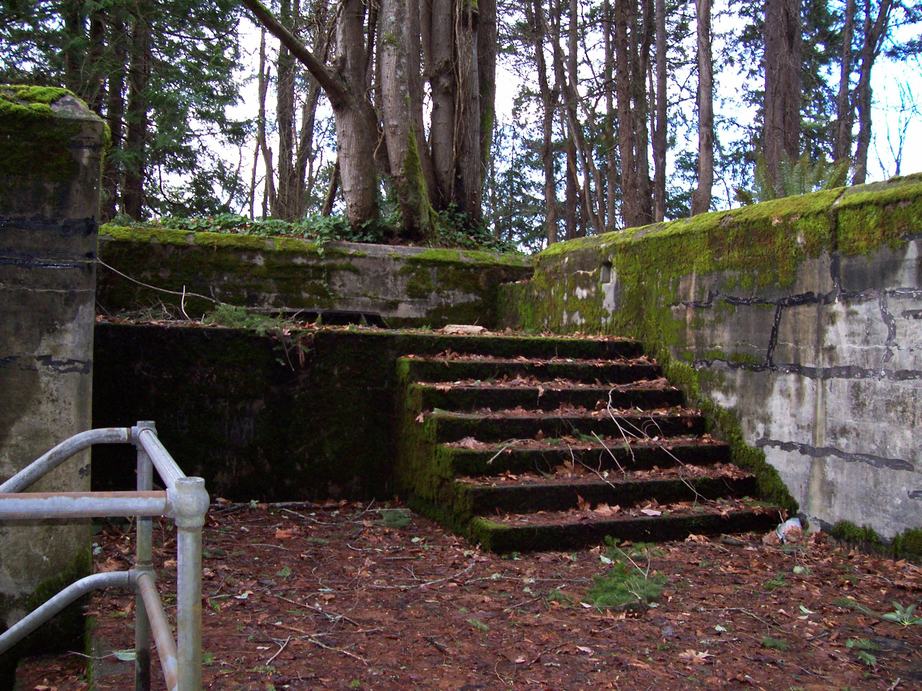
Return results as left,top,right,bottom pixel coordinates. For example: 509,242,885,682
0,422,209,691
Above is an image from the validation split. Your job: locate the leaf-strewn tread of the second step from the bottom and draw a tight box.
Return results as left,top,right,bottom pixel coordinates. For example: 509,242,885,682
455,463,752,491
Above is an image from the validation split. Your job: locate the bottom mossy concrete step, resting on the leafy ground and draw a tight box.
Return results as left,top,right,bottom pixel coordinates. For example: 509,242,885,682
470,505,778,552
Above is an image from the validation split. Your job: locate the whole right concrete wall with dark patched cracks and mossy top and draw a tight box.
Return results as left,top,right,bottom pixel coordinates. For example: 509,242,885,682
500,175,922,537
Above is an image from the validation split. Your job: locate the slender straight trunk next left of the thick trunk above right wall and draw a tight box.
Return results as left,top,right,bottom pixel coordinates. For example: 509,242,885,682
691,0,714,216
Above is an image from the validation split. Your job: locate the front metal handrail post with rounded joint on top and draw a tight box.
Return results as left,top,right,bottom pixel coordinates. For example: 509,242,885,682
167,477,209,691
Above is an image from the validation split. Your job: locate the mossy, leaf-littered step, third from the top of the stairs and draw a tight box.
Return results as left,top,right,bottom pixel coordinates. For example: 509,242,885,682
408,379,685,410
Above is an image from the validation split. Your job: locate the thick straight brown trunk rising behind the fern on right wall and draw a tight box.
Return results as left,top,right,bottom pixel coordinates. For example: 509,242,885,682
762,0,803,195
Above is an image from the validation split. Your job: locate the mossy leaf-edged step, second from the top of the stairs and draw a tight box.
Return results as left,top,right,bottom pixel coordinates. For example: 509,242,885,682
401,356,662,384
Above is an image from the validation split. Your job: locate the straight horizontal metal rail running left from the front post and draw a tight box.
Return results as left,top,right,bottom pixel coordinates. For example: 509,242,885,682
0,492,171,521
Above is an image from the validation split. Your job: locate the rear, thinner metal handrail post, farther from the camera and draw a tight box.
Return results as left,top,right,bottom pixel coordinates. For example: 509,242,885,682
131,421,157,691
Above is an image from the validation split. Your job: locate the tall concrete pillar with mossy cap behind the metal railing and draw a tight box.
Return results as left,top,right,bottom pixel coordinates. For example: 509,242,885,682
0,86,105,664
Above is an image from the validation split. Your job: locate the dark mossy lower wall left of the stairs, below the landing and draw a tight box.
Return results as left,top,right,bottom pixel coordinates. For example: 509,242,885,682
93,322,584,501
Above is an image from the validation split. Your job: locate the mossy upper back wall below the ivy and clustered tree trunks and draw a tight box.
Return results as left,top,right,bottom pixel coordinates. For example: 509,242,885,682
97,226,531,328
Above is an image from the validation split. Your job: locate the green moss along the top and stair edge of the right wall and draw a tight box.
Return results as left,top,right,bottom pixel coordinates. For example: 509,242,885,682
499,175,922,509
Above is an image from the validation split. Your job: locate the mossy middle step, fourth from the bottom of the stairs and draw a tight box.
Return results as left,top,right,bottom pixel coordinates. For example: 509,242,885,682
424,408,705,442
